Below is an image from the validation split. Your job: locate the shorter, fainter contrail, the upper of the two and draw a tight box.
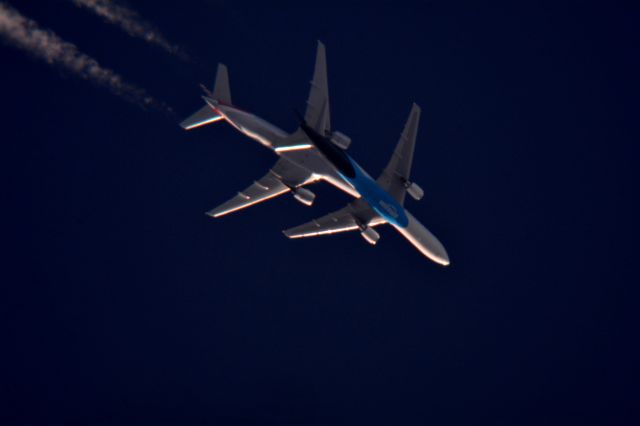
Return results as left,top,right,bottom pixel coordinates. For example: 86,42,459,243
71,0,188,60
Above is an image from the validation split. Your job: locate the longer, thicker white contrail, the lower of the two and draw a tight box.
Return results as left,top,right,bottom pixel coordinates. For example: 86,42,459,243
0,3,172,114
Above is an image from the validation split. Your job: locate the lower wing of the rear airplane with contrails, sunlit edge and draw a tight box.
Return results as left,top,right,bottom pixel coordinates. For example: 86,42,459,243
207,158,314,217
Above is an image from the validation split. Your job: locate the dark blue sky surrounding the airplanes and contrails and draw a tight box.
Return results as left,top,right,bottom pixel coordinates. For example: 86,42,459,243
0,1,640,425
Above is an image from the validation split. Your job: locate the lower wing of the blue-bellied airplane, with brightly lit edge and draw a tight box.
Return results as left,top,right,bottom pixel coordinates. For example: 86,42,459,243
283,200,386,238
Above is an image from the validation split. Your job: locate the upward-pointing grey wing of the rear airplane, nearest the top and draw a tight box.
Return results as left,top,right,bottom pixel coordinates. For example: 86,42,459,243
304,41,331,135
